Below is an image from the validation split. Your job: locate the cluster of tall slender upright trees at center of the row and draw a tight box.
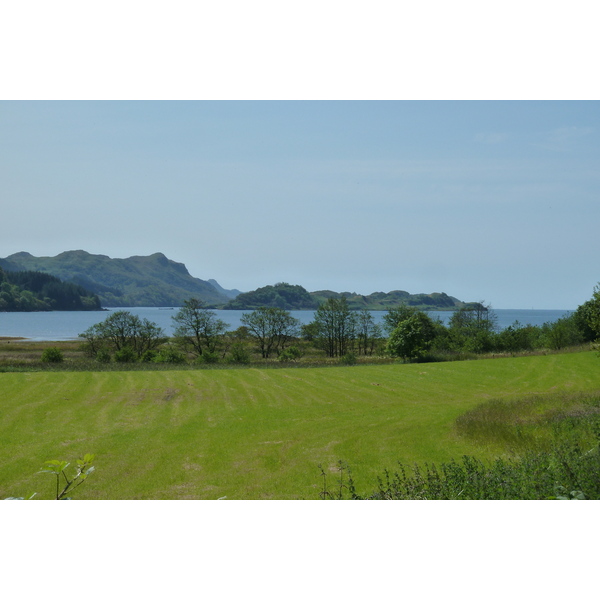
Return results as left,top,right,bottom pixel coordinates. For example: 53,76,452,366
313,297,356,357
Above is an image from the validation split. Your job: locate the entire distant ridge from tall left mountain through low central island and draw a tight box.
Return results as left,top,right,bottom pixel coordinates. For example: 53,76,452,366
0,250,477,310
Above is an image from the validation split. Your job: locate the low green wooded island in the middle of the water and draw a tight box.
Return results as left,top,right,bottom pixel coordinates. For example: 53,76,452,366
223,283,472,310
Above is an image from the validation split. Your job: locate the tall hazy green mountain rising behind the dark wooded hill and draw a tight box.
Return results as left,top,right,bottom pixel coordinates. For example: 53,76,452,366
0,250,231,307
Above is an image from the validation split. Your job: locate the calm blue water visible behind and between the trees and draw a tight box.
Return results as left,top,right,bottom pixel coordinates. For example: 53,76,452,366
0,308,572,341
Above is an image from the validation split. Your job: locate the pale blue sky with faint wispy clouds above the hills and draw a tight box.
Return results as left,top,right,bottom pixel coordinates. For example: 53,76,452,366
0,101,600,309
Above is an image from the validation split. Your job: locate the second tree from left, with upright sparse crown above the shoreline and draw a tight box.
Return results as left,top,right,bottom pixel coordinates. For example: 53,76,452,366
171,298,229,356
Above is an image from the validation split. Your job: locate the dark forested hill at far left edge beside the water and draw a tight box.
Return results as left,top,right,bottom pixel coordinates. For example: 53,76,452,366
0,267,101,312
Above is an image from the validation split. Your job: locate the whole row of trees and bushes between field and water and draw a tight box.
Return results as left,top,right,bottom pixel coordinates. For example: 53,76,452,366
80,285,600,364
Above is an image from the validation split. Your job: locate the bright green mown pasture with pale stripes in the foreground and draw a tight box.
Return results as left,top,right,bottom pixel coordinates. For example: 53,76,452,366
0,352,600,499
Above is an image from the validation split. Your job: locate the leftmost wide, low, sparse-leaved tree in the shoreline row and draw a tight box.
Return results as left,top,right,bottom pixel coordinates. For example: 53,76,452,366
79,310,166,358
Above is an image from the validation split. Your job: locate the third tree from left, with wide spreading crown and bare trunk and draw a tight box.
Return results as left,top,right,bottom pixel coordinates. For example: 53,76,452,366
240,307,300,358
